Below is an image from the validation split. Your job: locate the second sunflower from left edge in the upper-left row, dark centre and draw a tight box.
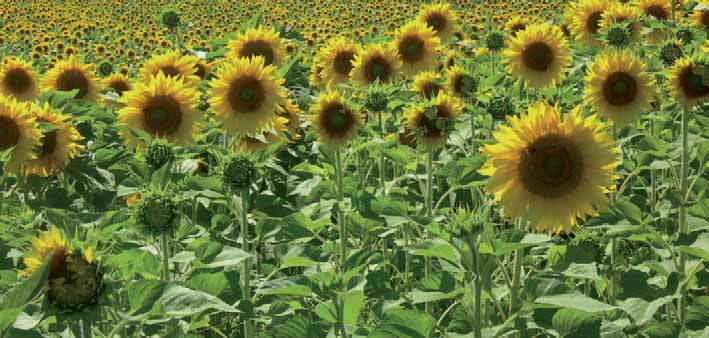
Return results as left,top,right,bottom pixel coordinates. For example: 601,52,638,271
43,55,97,101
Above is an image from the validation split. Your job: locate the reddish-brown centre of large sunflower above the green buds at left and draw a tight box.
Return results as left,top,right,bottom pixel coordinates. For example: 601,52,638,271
143,95,182,137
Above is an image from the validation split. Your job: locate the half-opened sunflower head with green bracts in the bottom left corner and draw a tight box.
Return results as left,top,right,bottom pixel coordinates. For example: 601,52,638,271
19,226,103,311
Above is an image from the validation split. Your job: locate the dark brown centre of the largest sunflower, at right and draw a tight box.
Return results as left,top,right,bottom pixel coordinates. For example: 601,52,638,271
518,134,584,198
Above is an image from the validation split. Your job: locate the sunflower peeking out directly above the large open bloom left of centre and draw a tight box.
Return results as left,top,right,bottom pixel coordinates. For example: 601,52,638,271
225,27,283,67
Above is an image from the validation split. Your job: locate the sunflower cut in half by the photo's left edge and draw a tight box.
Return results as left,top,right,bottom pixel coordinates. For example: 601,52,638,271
0,96,42,171
